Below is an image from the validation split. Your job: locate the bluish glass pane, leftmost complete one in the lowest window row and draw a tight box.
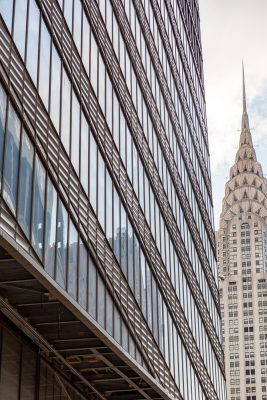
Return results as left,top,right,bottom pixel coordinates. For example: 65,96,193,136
3,105,20,212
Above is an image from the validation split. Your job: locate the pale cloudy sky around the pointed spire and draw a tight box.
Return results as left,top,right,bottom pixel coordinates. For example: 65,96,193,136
199,0,267,228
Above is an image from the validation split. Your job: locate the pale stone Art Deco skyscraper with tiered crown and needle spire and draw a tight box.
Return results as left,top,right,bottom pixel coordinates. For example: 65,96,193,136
217,72,267,400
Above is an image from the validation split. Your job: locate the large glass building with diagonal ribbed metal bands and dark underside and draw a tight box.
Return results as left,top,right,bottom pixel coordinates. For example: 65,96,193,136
0,0,226,400
